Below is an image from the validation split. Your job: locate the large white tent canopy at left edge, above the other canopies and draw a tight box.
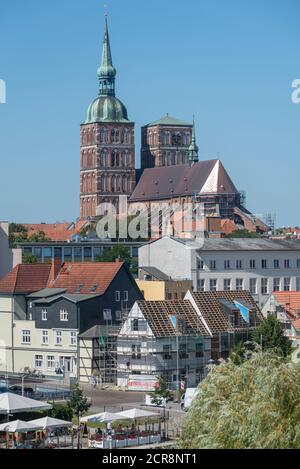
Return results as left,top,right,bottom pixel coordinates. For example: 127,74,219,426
0,392,52,415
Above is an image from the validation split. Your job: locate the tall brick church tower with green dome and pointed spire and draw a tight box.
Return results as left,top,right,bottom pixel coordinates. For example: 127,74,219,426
80,18,135,219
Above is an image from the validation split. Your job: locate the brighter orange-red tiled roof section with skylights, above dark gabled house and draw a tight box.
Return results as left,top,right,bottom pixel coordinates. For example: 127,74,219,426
49,262,124,295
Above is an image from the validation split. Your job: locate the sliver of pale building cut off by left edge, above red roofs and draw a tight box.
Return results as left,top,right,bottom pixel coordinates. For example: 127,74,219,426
0,222,22,279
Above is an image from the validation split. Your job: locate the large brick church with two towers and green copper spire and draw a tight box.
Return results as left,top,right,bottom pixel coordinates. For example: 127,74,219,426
80,18,268,236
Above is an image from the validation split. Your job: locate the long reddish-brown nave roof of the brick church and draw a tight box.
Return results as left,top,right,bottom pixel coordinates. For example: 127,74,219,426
130,160,238,202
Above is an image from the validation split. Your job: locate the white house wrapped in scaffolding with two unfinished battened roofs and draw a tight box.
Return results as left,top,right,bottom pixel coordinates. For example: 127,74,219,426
117,291,263,389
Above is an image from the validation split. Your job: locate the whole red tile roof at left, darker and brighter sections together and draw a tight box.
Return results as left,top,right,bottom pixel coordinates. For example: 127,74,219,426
0,262,123,295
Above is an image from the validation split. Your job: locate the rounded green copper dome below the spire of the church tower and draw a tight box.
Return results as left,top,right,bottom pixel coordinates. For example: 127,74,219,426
85,96,129,124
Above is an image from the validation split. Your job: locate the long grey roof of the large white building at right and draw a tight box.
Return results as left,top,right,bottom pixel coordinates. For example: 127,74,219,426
162,238,300,251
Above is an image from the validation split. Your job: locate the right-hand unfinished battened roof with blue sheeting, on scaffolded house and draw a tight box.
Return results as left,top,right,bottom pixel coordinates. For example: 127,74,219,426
191,291,263,334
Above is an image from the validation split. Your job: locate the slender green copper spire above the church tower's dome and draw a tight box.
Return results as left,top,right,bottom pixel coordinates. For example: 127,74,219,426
98,15,117,96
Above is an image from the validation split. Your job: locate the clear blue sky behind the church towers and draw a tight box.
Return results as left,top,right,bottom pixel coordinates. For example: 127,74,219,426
0,0,300,225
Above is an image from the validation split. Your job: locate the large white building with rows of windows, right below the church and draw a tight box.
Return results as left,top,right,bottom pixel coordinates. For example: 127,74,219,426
139,236,300,306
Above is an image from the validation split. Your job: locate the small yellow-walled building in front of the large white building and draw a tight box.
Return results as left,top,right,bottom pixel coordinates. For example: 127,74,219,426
136,267,193,301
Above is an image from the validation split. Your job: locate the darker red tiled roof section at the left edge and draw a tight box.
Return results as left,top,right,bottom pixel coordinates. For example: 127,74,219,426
0,264,51,294
